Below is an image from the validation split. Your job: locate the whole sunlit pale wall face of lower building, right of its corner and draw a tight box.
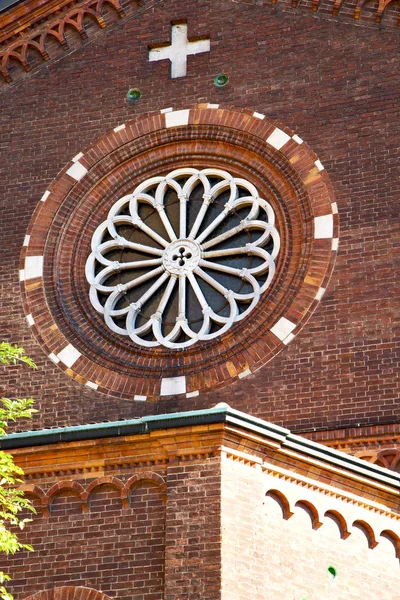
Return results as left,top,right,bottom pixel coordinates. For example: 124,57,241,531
222,457,400,600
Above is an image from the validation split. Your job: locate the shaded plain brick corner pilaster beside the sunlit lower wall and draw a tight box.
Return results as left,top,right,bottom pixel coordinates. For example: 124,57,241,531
165,457,221,600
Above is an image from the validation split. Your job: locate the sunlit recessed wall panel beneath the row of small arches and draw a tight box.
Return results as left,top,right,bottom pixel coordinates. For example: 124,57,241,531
262,499,400,600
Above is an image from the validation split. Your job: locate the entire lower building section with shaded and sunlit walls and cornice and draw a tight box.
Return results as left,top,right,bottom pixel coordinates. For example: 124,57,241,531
0,418,400,600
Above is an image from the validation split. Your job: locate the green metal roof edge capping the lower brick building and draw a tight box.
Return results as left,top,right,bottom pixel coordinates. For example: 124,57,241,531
0,404,400,491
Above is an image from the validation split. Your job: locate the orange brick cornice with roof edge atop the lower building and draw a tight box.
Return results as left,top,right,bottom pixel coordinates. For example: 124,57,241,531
3,405,400,510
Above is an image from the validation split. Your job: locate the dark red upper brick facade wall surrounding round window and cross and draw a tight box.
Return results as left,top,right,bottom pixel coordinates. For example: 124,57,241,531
0,0,400,430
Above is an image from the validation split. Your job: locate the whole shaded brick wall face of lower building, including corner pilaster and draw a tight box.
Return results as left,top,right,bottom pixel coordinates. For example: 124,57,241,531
0,444,221,600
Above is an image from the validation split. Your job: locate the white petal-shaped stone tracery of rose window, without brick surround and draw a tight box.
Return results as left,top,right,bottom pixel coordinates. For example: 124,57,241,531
86,168,280,349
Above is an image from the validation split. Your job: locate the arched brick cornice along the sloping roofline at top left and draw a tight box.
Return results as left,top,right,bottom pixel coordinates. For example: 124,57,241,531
0,0,125,83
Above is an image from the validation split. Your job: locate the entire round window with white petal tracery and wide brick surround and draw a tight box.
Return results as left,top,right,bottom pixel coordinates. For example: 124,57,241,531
19,104,339,405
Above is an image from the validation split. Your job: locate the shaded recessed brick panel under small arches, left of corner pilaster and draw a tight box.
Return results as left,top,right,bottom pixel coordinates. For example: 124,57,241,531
2,478,165,600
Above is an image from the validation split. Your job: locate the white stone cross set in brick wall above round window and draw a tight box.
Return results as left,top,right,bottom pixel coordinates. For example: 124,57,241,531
149,23,210,79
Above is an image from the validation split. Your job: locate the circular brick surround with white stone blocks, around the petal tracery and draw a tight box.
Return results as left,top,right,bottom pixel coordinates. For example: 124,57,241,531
20,105,338,400
